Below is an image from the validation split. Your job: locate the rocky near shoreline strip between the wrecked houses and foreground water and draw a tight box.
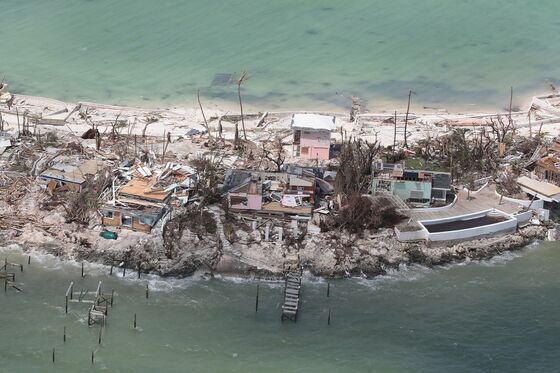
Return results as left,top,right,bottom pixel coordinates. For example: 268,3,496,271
2,221,548,281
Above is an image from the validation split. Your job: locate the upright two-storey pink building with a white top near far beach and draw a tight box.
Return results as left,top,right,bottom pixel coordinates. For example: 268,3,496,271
292,114,335,160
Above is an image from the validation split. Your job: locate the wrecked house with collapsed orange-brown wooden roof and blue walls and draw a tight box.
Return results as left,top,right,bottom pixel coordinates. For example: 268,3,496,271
101,177,172,233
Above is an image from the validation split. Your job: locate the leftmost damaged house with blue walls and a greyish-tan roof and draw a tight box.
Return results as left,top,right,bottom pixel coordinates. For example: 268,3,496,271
39,160,102,192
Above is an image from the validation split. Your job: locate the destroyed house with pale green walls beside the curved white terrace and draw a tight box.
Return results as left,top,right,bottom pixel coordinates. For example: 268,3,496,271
371,162,451,207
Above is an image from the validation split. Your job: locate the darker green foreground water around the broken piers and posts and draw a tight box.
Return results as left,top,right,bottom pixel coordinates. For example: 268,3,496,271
0,242,560,372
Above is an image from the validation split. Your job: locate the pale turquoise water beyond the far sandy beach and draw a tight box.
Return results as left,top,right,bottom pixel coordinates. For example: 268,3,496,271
0,0,560,109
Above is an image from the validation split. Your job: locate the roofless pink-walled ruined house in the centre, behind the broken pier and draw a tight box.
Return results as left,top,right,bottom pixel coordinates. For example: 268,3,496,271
224,170,315,215
